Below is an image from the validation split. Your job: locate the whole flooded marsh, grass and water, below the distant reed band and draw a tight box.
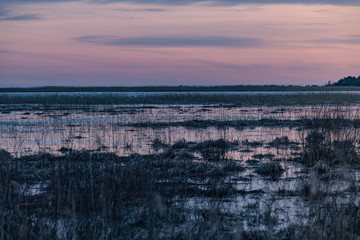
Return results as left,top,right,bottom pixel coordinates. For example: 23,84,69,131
0,94,360,239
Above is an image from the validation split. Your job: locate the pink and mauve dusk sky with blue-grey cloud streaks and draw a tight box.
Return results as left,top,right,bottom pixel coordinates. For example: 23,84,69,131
0,0,360,87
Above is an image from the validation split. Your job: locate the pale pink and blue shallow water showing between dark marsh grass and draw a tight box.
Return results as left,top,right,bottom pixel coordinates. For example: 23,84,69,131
0,102,360,230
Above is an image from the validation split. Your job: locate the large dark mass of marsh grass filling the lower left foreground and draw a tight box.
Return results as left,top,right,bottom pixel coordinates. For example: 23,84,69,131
0,140,243,239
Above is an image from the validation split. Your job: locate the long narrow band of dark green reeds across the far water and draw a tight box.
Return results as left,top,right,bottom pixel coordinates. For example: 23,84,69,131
0,90,360,107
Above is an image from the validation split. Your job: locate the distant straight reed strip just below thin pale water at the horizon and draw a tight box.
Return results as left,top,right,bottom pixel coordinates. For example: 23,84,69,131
0,90,360,107
